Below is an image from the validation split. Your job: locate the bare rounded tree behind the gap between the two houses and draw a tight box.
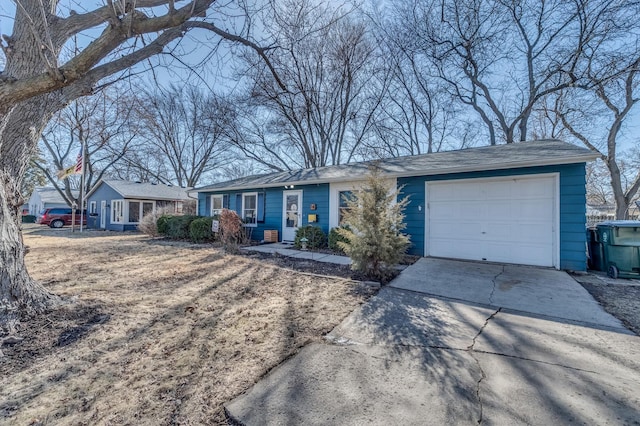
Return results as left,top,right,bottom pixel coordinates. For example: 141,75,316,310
127,86,233,187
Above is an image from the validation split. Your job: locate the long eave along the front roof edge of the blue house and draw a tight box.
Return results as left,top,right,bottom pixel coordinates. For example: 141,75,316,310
192,153,599,193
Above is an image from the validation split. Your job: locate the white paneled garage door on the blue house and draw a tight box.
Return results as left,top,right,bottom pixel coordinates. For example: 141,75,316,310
425,175,557,266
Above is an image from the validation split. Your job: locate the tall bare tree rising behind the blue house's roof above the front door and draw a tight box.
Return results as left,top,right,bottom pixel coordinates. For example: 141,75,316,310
234,0,385,170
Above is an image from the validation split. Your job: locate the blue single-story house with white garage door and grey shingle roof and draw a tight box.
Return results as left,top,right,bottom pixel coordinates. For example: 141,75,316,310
194,140,596,270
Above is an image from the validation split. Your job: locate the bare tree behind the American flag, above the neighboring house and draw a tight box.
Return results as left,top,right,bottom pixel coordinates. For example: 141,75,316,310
35,86,136,210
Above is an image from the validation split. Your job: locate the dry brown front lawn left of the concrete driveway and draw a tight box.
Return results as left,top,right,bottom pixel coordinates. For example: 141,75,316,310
0,225,374,425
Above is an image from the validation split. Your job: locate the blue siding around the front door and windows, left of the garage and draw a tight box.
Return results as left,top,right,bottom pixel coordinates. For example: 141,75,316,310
198,183,329,241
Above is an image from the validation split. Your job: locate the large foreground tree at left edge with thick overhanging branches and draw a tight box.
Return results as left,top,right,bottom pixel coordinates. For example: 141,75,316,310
0,0,280,313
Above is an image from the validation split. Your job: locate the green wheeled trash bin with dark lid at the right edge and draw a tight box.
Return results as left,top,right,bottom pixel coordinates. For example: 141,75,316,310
589,220,640,278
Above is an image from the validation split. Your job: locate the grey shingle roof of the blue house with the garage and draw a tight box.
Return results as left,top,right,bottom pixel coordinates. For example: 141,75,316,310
193,140,597,191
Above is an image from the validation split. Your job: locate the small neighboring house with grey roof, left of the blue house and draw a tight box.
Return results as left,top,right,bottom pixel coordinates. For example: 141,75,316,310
86,179,190,231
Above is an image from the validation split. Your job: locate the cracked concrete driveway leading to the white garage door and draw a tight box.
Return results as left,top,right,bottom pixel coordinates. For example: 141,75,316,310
226,259,640,425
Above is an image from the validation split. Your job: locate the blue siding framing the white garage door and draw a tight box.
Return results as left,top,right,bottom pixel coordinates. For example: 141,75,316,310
398,163,586,271
